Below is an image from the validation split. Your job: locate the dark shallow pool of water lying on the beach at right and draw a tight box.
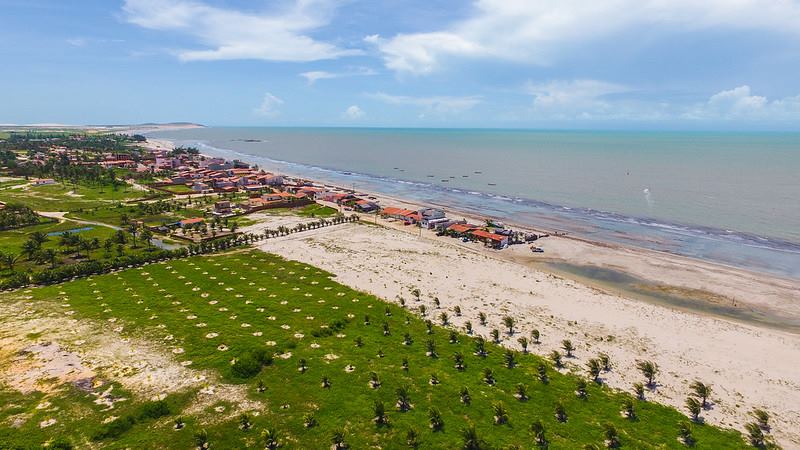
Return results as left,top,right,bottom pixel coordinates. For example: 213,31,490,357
542,262,800,333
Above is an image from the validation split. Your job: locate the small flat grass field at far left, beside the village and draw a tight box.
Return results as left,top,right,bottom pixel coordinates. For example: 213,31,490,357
0,184,145,211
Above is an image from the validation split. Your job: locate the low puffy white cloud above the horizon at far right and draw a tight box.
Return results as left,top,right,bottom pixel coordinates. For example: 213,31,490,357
682,85,800,121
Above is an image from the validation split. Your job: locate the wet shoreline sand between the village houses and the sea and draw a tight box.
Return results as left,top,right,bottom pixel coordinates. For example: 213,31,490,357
148,137,800,334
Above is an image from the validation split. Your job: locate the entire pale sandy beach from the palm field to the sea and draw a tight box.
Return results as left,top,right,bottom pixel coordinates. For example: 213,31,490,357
151,134,800,448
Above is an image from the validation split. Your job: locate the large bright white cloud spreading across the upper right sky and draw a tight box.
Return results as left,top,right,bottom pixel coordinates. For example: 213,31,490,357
372,0,800,74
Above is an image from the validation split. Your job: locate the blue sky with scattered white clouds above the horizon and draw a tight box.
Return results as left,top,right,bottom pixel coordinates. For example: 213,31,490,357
0,0,800,131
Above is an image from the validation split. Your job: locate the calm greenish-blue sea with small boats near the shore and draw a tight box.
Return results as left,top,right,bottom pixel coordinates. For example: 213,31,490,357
151,127,800,278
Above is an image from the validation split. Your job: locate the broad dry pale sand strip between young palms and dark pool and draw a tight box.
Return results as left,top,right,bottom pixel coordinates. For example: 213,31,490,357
255,224,800,448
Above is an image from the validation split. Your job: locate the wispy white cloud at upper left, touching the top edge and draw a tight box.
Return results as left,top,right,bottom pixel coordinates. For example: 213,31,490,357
123,0,361,61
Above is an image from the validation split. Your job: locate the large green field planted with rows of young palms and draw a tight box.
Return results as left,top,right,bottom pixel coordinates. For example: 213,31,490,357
0,251,744,449
